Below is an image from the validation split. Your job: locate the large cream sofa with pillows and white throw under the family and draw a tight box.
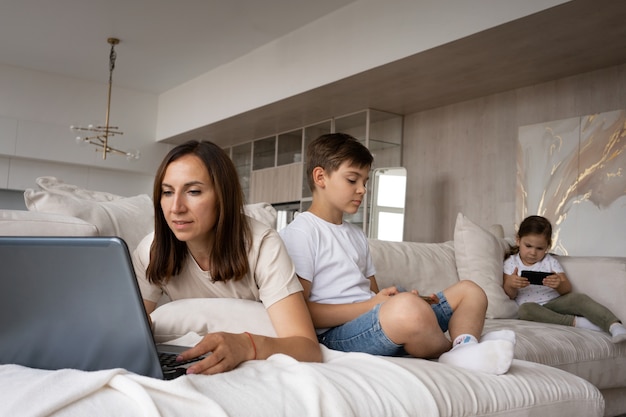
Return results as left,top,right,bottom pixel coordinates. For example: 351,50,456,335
0,178,626,417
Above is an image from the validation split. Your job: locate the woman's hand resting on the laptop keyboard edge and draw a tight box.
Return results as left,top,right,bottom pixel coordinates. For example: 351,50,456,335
179,332,256,375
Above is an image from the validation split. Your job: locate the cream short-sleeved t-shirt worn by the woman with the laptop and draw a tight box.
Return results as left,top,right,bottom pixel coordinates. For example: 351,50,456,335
133,218,302,308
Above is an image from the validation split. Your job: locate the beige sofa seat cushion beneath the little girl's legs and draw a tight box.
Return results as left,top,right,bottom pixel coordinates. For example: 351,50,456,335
484,320,626,389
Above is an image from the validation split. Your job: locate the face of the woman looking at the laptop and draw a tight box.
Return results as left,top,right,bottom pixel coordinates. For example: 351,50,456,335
161,154,218,248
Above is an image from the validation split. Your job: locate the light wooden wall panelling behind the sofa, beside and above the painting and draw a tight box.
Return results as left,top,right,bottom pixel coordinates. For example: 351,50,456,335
403,65,626,242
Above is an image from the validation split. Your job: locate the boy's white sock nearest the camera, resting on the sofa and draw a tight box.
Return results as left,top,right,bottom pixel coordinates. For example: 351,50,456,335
439,335,515,375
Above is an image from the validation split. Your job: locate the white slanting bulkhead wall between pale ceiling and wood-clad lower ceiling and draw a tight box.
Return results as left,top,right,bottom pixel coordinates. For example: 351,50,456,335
156,0,566,140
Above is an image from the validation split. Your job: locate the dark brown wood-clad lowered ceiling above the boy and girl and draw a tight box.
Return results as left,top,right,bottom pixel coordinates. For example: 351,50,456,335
166,0,626,146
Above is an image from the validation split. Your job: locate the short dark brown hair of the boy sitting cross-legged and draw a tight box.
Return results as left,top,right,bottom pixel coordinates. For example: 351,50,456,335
306,133,374,191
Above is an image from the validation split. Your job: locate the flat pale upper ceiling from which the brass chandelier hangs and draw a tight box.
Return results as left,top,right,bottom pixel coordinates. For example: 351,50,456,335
0,0,354,94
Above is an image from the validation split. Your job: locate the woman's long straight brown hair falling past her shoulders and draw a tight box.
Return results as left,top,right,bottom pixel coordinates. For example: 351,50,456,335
146,140,252,285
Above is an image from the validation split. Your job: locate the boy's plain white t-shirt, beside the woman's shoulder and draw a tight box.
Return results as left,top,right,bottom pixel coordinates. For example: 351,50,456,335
280,212,376,304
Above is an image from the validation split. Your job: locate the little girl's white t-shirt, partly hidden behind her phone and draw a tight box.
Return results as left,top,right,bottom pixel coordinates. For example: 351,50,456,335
504,253,564,305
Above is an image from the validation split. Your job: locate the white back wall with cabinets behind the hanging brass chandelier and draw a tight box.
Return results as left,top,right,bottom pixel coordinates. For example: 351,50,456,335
0,65,170,195
